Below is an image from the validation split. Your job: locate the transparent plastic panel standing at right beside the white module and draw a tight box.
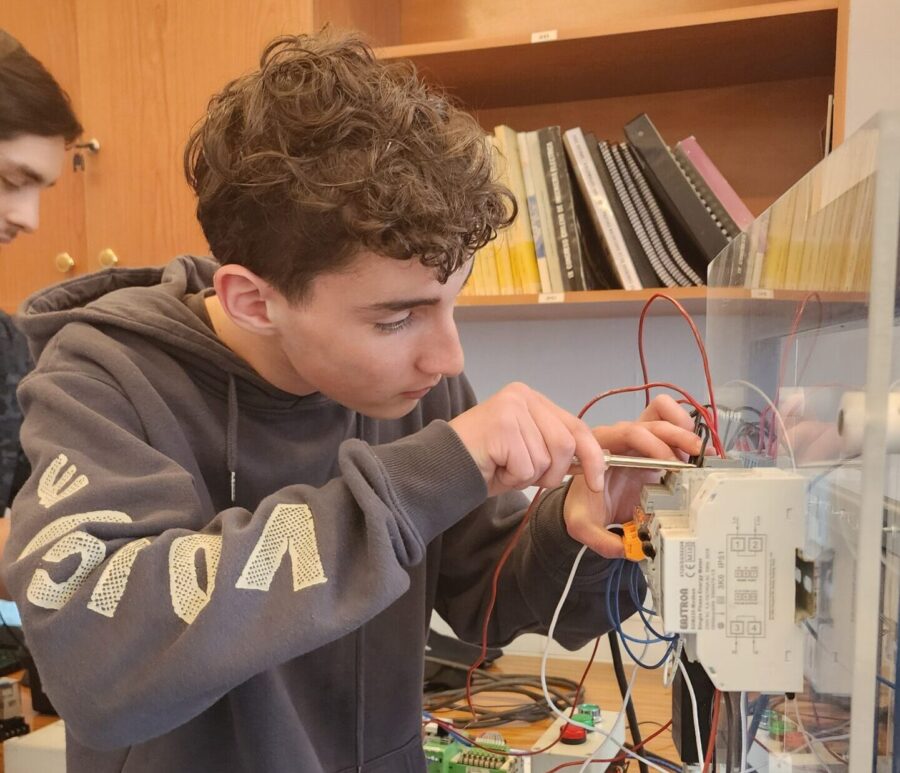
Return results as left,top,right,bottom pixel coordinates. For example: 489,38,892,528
706,113,900,771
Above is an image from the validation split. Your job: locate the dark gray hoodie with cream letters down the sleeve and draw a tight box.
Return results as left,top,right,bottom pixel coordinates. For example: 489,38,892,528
4,257,632,773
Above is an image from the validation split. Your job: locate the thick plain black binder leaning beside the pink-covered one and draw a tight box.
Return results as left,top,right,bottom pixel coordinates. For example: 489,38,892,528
625,113,729,277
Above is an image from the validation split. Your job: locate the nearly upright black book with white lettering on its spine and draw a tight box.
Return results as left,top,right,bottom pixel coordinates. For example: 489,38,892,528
537,126,585,292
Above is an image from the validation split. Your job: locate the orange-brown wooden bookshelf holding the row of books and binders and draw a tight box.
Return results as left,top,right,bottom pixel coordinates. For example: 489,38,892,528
314,0,848,320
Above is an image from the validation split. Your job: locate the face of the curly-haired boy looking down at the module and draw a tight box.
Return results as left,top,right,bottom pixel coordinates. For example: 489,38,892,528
269,253,471,419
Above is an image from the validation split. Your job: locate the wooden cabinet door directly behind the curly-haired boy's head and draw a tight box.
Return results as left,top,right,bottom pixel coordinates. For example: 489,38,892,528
74,0,312,270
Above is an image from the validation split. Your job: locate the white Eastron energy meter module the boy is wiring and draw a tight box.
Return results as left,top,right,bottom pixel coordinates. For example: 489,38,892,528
636,467,814,692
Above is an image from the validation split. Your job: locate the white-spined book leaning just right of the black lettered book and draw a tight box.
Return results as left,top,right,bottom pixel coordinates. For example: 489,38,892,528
564,127,642,290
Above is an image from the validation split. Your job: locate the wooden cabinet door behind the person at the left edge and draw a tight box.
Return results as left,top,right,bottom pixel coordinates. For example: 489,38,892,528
0,0,88,312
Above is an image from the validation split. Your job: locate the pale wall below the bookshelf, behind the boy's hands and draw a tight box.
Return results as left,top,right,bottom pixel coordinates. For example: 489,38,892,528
434,316,707,660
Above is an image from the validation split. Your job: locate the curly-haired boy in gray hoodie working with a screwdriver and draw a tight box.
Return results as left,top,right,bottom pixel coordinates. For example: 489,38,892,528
8,30,699,773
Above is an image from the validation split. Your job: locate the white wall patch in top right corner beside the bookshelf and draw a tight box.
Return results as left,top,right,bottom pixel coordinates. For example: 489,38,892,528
845,0,900,137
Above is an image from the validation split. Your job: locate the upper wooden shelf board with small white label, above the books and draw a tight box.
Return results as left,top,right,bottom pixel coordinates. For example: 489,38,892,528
378,0,837,109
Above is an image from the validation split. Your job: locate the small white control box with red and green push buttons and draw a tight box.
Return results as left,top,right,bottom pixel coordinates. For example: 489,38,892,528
531,704,625,773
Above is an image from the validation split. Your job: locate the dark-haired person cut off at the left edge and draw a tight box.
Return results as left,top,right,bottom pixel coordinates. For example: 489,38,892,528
0,29,81,598
